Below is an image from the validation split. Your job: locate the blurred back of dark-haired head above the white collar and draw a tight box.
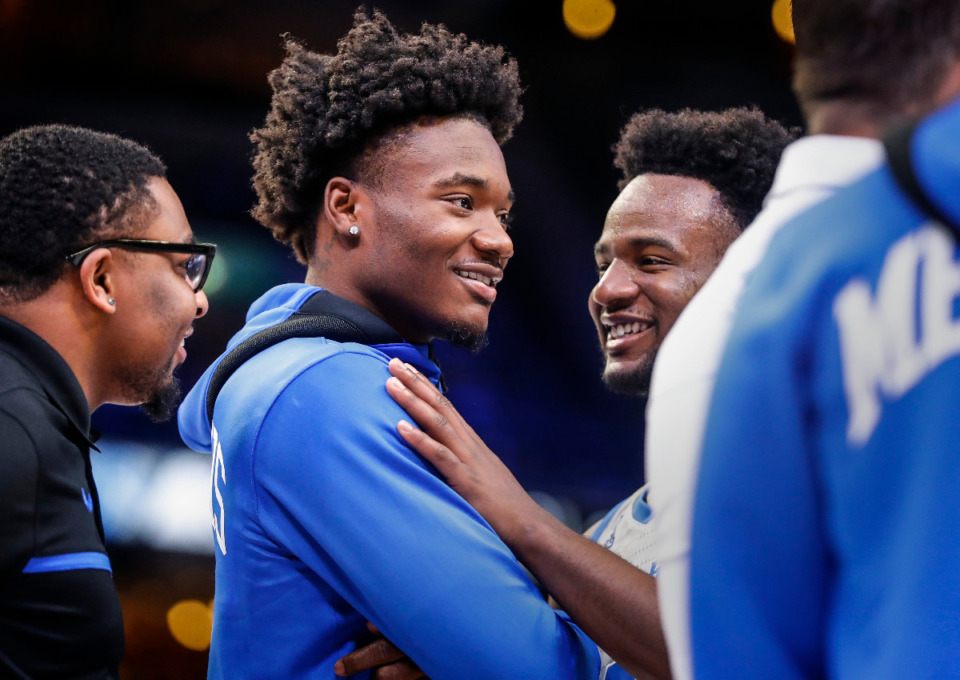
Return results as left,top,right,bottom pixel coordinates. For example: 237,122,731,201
793,0,960,128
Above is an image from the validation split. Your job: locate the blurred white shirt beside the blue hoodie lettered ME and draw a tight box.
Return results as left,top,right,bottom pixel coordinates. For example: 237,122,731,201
645,135,884,680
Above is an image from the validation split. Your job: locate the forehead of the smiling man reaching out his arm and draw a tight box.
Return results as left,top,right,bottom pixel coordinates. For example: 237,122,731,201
596,174,724,252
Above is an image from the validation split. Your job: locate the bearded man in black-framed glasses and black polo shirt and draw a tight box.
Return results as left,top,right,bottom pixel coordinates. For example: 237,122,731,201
0,125,216,678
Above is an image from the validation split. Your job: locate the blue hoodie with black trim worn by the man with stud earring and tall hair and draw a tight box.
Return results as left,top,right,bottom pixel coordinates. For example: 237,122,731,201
179,284,600,680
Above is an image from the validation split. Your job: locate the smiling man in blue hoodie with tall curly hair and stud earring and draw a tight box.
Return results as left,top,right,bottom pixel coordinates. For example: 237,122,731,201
180,12,612,680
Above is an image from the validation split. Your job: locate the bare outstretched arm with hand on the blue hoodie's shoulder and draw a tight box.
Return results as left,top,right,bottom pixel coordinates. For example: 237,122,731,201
387,360,669,677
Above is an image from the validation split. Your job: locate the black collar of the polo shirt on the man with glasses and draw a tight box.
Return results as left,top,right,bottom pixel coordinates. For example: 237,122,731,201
0,316,93,446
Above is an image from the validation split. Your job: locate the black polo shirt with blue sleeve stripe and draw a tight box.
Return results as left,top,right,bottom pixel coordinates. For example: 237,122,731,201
0,317,123,679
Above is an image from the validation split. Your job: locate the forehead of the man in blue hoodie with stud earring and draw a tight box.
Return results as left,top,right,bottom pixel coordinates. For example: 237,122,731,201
374,118,509,190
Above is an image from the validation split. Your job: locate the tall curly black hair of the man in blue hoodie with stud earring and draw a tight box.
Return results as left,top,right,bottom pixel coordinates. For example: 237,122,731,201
251,8,523,263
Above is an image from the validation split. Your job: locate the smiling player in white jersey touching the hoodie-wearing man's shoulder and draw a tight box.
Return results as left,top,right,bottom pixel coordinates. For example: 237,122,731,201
334,108,792,680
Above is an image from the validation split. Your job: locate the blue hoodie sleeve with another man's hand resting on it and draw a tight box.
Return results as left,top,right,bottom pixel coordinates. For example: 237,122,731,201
248,351,599,680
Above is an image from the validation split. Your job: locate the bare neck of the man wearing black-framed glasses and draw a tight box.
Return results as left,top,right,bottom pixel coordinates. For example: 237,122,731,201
0,282,105,413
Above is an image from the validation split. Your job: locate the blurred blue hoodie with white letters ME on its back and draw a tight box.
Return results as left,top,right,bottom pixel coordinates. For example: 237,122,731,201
690,102,960,680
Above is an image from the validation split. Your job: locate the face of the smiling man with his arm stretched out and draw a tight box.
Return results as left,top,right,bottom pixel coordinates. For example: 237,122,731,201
589,174,740,396
